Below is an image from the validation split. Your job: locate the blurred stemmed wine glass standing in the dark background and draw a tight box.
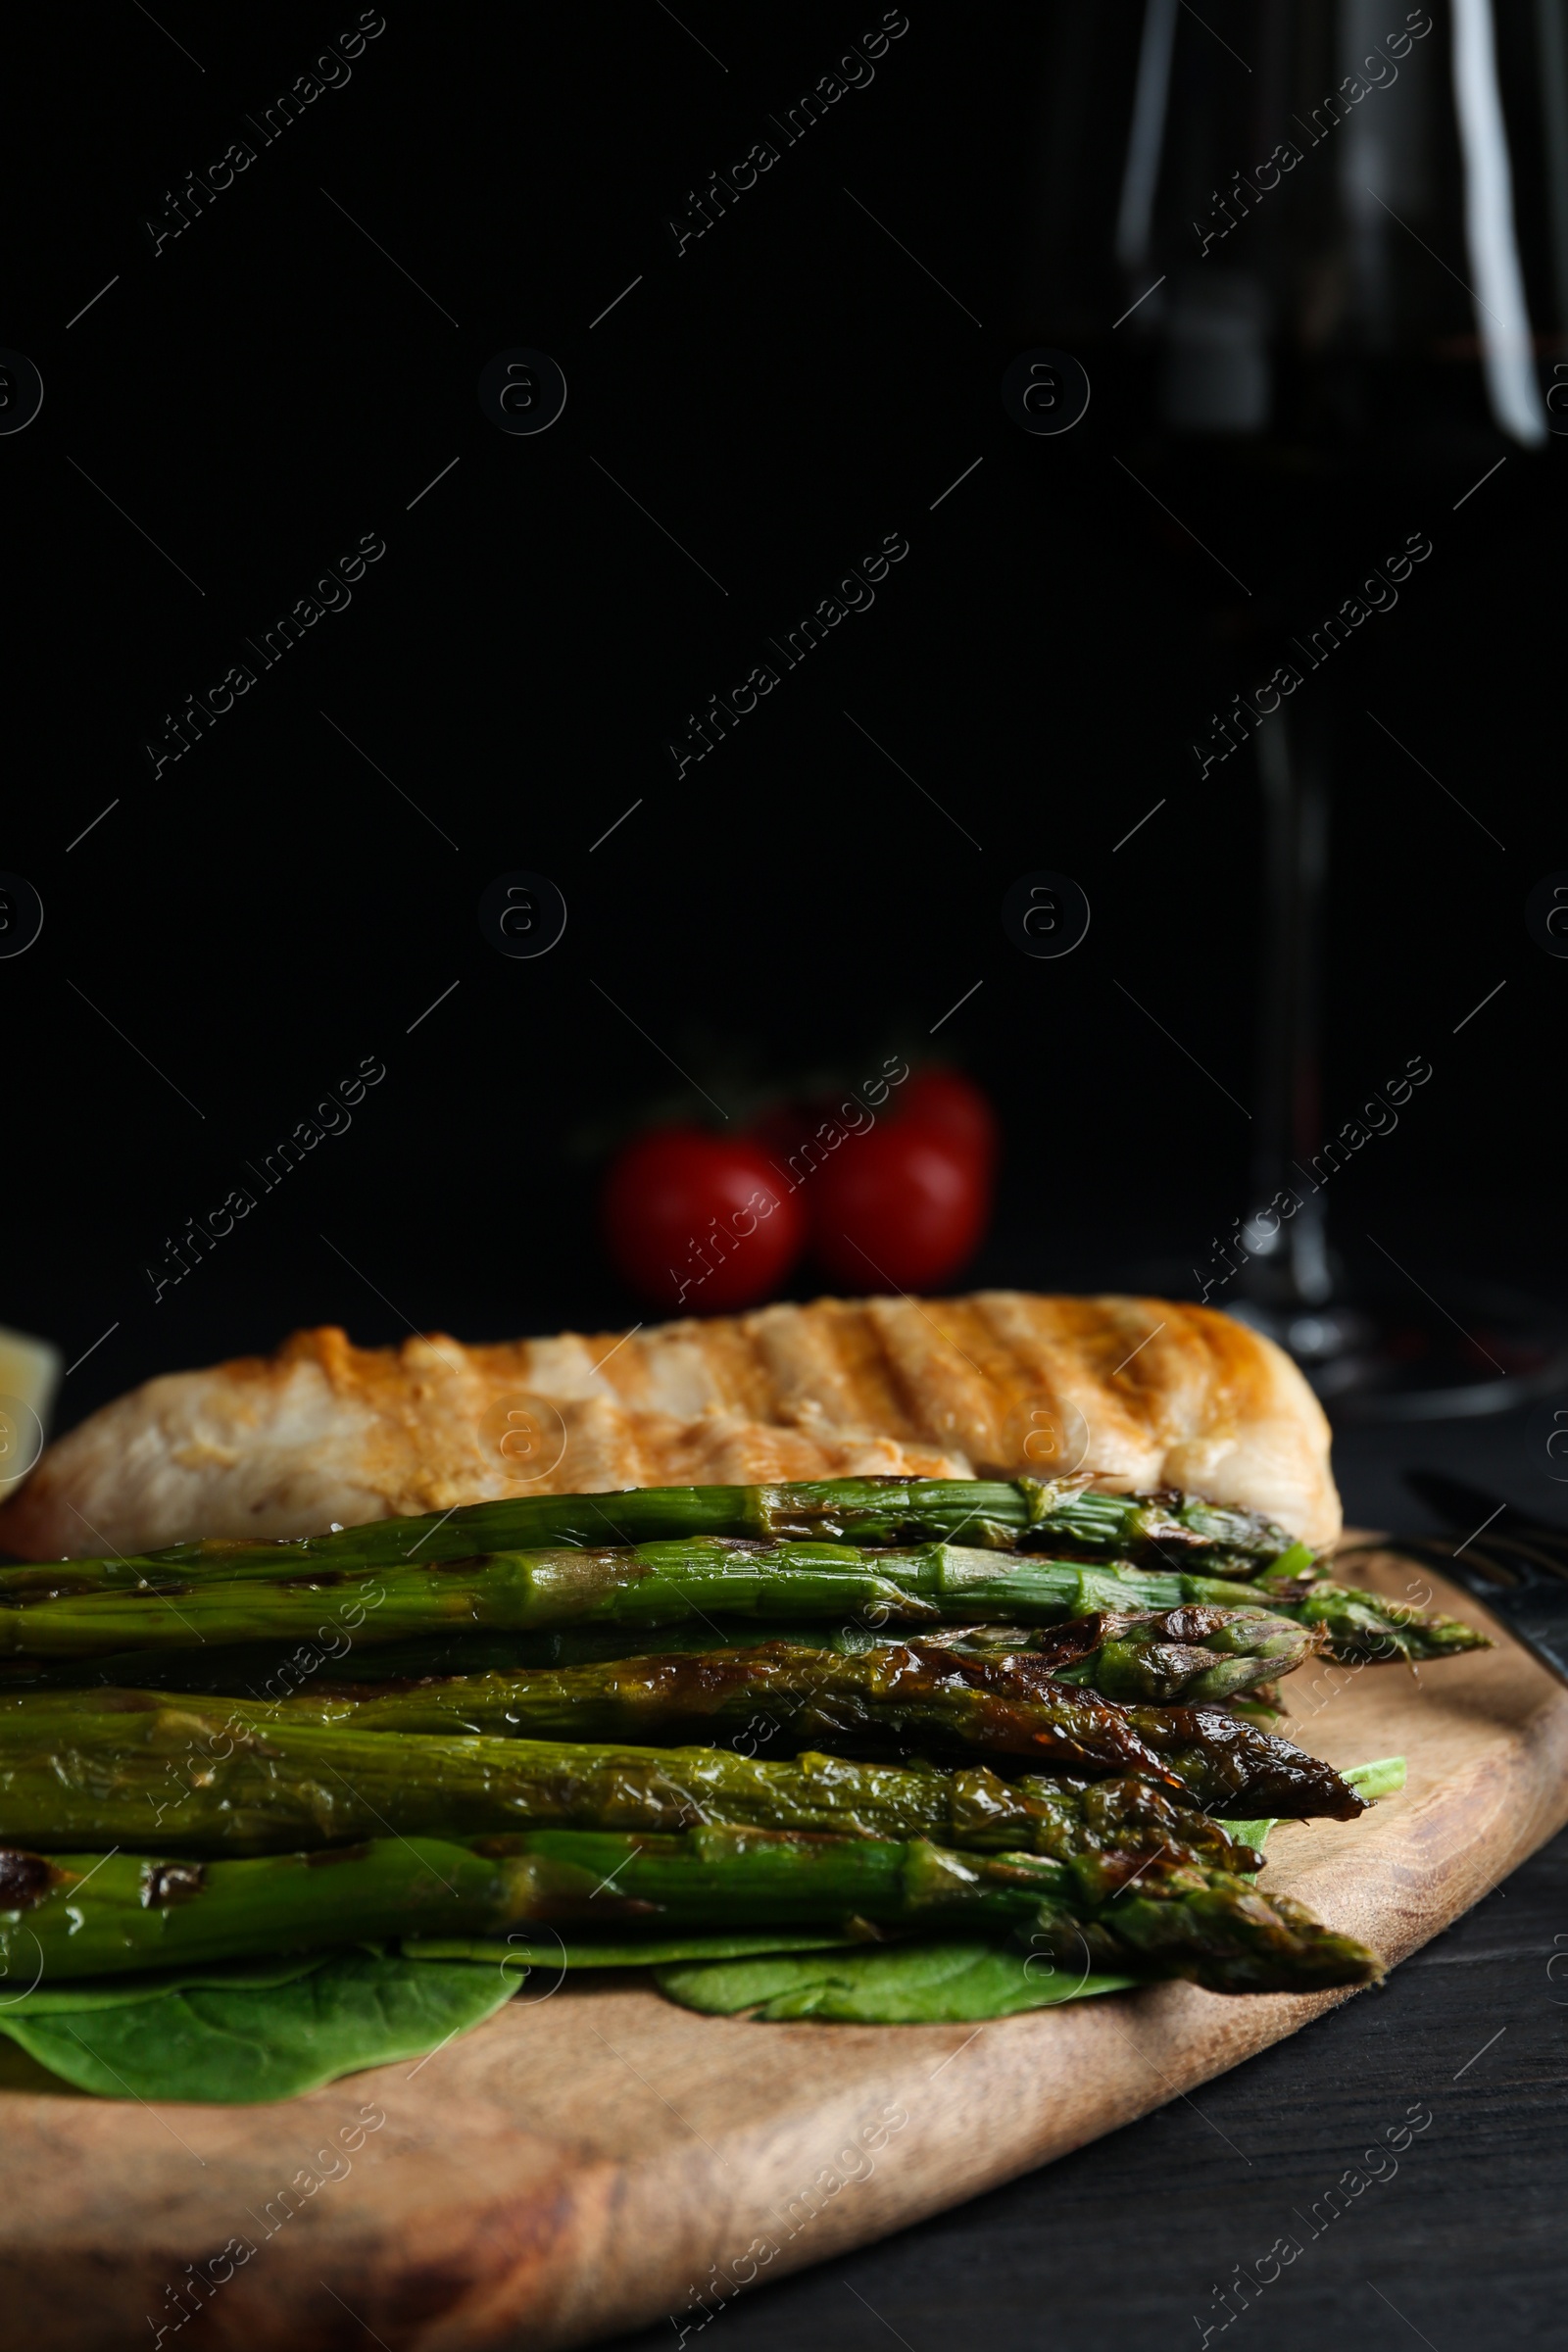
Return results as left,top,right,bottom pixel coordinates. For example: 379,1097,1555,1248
1022,0,1568,1418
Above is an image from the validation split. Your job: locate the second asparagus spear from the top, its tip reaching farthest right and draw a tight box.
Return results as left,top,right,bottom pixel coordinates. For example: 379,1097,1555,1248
0,1543,1484,1658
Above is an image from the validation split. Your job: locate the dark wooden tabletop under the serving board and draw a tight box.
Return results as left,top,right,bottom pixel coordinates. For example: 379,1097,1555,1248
615,1416,1568,2352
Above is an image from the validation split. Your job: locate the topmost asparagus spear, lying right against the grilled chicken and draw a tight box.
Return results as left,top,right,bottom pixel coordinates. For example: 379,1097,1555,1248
0,1477,1312,1599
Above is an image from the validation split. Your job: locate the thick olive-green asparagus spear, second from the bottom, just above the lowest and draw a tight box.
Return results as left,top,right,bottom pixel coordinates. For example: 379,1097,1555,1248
0,1691,1260,1870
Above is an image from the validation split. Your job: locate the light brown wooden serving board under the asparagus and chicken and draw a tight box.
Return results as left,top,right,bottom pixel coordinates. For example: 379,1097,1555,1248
0,1557,1568,2352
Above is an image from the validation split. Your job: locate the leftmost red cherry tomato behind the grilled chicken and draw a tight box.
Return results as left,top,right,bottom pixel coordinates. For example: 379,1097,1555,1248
602,1127,807,1315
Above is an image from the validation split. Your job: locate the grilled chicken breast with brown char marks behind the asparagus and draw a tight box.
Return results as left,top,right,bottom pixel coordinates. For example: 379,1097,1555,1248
0,1292,1340,1559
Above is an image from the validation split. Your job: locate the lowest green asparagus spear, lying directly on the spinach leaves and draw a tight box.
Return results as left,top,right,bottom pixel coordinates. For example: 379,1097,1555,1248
0,1830,1380,1992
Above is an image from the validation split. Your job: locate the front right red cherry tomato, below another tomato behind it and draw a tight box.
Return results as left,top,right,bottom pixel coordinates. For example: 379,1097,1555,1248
807,1119,990,1292
